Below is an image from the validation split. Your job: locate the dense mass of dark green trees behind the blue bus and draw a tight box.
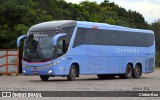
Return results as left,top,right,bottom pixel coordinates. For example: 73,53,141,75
0,0,150,49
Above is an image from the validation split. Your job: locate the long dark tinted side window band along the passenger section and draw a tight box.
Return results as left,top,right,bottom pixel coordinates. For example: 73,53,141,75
73,28,154,47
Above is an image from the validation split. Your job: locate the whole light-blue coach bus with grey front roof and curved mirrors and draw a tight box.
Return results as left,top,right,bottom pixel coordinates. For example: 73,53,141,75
17,20,155,81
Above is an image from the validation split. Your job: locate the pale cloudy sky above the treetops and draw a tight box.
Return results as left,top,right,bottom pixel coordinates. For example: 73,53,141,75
65,0,160,23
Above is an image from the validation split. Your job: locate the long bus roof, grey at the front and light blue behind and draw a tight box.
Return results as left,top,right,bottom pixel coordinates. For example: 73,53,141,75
29,20,153,33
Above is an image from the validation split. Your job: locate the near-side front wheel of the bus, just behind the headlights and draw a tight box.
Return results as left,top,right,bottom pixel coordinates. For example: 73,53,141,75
67,65,77,81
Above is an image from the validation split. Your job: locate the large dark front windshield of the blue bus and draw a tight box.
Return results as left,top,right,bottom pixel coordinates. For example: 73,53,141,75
23,31,58,62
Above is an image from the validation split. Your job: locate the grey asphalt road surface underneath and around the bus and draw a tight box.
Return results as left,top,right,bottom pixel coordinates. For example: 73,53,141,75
0,69,160,100
